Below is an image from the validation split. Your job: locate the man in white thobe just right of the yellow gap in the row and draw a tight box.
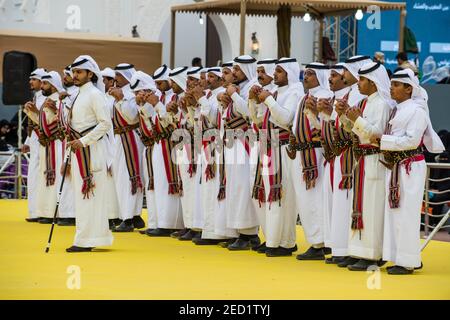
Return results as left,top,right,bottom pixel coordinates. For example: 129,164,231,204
289,62,333,260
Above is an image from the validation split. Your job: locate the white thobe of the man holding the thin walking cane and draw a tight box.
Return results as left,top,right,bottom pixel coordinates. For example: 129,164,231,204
69,82,113,247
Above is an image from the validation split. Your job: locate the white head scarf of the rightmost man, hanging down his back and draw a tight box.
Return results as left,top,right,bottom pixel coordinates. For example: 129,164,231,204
391,69,445,153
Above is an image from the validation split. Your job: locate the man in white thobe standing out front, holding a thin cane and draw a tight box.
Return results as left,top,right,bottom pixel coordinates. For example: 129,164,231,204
66,55,113,252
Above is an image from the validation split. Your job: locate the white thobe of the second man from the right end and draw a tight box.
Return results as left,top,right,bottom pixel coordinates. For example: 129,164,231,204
348,92,391,260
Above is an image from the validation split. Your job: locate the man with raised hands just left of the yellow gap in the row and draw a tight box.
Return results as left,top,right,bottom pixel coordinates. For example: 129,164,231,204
254,58,304,257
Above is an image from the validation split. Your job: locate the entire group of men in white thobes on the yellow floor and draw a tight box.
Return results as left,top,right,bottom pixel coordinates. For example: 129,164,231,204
24,55,444,274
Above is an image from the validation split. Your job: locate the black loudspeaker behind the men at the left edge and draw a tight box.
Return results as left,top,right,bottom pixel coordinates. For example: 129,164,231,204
2,51,37,105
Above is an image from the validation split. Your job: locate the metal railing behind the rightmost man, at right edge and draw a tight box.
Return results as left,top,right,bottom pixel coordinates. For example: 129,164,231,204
421,163,450,250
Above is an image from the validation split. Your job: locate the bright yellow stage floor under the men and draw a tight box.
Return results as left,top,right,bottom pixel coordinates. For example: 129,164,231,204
0,200,450,299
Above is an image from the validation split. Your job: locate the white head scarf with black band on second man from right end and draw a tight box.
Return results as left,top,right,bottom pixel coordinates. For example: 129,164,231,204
358,62,396,108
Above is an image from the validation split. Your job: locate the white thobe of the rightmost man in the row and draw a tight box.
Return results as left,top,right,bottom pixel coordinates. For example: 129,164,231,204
380,99,427,268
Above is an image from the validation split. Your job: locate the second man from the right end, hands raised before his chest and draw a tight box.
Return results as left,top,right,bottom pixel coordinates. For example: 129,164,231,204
344,62,395,271
